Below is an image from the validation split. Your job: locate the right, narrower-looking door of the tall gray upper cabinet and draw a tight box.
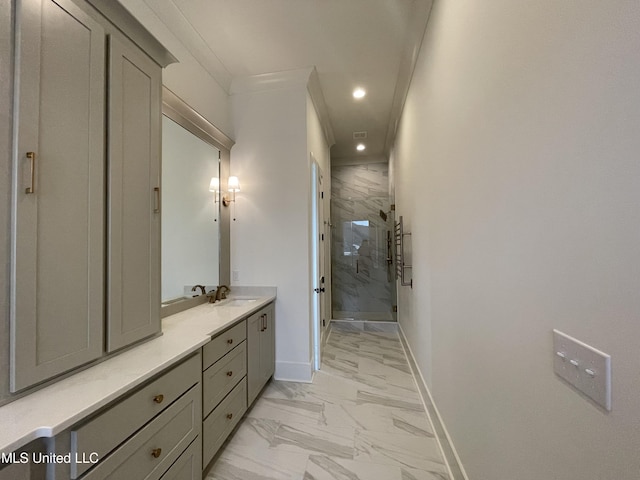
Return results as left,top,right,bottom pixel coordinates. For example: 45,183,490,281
107,35,162,352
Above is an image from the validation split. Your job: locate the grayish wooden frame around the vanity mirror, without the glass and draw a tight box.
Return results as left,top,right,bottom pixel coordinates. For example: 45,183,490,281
160,86,235,318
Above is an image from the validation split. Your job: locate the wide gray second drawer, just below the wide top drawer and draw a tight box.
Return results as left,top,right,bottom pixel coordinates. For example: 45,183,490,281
82,384,202,480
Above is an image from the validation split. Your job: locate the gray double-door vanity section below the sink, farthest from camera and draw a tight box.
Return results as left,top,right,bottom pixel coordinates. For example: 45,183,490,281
247,303,275,405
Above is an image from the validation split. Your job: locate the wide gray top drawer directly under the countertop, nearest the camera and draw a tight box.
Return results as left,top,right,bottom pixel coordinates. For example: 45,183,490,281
71,353,201,478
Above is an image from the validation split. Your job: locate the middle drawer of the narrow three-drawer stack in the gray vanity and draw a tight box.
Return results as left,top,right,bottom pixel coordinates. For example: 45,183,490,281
202,341,247,416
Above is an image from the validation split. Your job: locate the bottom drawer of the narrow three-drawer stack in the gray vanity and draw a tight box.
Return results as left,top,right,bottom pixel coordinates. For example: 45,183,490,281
202,378,247,467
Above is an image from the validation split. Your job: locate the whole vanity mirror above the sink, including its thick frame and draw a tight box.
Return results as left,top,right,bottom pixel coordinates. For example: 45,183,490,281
161,88,233,317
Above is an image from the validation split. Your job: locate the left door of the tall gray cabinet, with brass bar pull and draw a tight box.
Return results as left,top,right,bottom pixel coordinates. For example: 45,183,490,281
11,0,105,392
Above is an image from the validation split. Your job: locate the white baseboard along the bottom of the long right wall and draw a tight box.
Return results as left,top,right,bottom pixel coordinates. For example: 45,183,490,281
398,323,469,480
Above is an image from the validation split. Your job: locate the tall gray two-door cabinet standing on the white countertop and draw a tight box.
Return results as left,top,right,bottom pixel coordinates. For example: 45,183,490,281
11,0,171,392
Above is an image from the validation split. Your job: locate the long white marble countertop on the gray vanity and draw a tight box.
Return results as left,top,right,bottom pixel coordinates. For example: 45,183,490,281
0,287,275,453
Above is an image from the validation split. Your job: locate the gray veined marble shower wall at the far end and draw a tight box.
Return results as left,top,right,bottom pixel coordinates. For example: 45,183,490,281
331,163,393,320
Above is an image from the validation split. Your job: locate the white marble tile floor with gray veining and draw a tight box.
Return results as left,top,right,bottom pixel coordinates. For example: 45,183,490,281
206,324,450,480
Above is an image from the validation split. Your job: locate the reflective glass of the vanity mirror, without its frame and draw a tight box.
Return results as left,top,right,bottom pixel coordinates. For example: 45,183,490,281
161,115,220,304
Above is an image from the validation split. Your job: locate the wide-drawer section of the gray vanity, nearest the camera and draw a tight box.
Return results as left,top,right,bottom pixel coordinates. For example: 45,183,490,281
52,352,202,480
